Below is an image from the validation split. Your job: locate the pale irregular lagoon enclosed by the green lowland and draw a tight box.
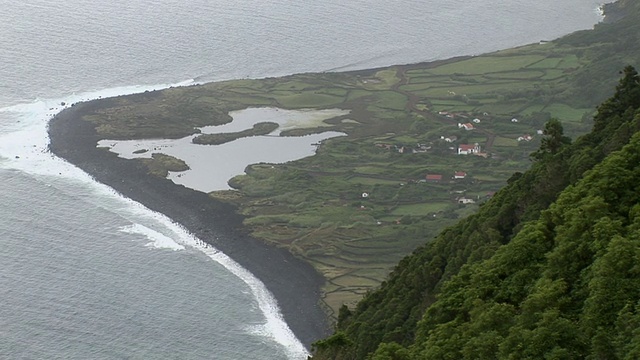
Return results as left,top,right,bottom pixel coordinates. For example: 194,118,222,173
98,107,349,192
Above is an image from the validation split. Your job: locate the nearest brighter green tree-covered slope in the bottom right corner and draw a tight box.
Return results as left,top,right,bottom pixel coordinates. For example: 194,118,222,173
412,86,640,359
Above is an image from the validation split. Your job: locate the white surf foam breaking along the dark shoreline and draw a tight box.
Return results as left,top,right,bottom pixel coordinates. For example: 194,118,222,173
0,85,308,359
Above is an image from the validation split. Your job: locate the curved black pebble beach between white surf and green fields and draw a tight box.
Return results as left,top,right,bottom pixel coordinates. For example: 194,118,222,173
49,93,330,348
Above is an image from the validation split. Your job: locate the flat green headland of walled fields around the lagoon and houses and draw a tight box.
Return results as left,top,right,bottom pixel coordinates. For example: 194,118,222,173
77,0,638,320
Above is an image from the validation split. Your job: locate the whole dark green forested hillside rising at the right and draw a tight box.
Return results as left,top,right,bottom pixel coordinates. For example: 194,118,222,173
314,13,640,360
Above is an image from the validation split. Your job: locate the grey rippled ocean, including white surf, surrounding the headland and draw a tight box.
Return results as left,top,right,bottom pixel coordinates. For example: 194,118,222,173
0,0,601,359
